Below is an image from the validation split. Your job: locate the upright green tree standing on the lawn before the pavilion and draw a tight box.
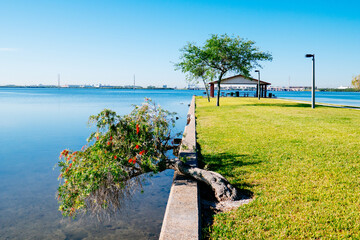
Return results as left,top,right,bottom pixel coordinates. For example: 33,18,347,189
177,34,272,106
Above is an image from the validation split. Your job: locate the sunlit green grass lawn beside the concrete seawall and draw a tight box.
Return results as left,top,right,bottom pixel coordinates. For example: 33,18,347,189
196,98,360,239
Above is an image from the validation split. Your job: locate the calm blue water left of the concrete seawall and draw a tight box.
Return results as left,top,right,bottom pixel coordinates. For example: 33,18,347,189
0,88,202,239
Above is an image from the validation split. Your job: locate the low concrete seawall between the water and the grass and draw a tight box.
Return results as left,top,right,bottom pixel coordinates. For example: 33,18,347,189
160,97,201,240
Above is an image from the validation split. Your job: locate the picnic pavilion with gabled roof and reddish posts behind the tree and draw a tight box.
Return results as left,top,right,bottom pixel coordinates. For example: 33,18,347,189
209,74,271,98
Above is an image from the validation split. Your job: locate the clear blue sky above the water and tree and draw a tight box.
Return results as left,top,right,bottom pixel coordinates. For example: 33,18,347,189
0,0,360,87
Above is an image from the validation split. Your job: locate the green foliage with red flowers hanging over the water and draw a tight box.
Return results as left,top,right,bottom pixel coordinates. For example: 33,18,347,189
58,99,175,217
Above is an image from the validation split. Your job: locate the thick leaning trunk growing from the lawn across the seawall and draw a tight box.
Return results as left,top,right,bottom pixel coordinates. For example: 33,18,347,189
168,160,240,202
